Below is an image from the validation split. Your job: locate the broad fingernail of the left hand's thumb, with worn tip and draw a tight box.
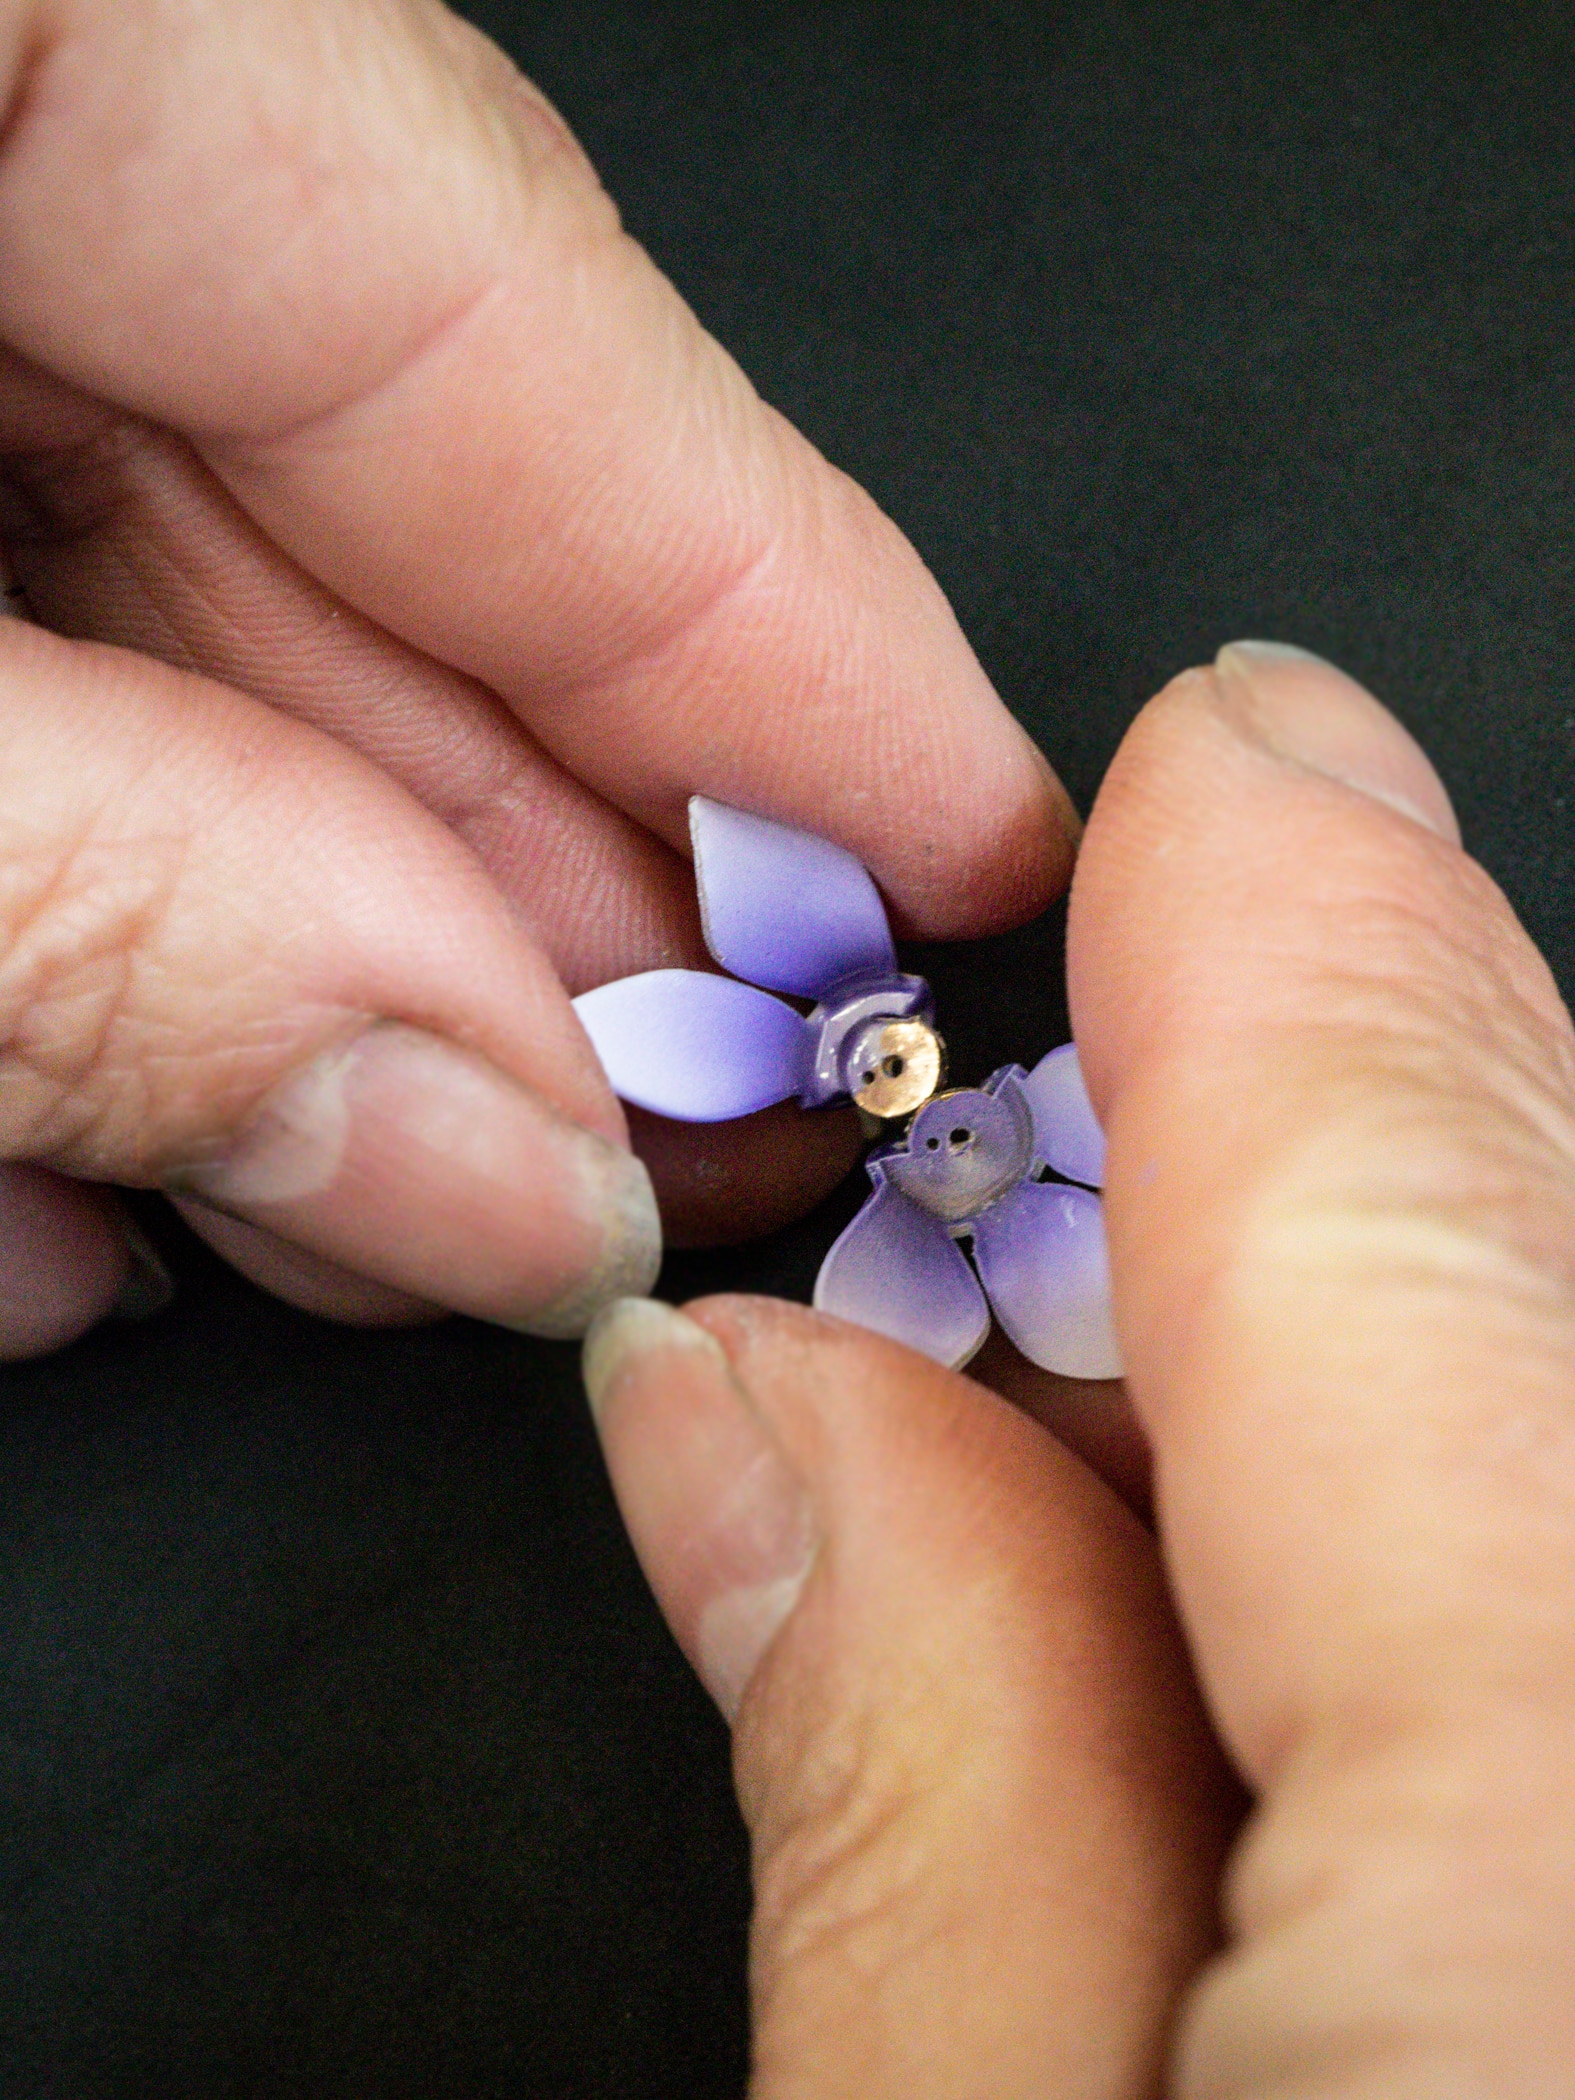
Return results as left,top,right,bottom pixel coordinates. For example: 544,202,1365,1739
168,1023,662,1340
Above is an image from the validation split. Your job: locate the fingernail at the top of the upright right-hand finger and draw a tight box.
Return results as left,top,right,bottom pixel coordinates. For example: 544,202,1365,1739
1214,641,1460,846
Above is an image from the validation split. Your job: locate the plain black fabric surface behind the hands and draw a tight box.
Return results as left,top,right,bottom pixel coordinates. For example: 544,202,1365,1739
0,0,1575,2100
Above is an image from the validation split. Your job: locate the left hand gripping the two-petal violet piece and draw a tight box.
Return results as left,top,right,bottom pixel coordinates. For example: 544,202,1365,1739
0,0,1073,1357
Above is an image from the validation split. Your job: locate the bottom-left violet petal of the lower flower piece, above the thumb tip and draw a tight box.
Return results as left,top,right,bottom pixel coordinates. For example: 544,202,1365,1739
815,1182,989,1371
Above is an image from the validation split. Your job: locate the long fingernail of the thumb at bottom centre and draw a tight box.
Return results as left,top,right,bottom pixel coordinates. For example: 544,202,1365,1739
584,1298,817,1722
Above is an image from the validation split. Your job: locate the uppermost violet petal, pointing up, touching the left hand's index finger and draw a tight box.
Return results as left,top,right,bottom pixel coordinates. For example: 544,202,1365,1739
689,794,897,1000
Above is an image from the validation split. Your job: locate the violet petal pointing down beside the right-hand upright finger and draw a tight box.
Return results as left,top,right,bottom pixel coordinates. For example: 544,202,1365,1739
972,1180,1121,1378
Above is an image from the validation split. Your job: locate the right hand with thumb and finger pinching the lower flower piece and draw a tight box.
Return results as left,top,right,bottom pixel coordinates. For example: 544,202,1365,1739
586,649,1575,2100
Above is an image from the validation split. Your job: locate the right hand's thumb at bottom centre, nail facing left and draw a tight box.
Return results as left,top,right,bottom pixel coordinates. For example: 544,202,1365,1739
586,1298,1233,2100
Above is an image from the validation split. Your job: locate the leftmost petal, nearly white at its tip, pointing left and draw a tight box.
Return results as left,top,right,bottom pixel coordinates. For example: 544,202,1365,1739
573,970,813,1124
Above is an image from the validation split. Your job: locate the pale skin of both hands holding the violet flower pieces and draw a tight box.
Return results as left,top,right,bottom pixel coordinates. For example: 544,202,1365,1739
0,0,1575,2100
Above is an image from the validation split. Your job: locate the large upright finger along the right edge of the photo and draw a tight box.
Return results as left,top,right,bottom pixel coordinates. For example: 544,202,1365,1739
1069,645,1575,2100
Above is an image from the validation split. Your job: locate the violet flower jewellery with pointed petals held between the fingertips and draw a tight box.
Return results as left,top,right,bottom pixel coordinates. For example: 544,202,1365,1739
573,796,1119,1378
